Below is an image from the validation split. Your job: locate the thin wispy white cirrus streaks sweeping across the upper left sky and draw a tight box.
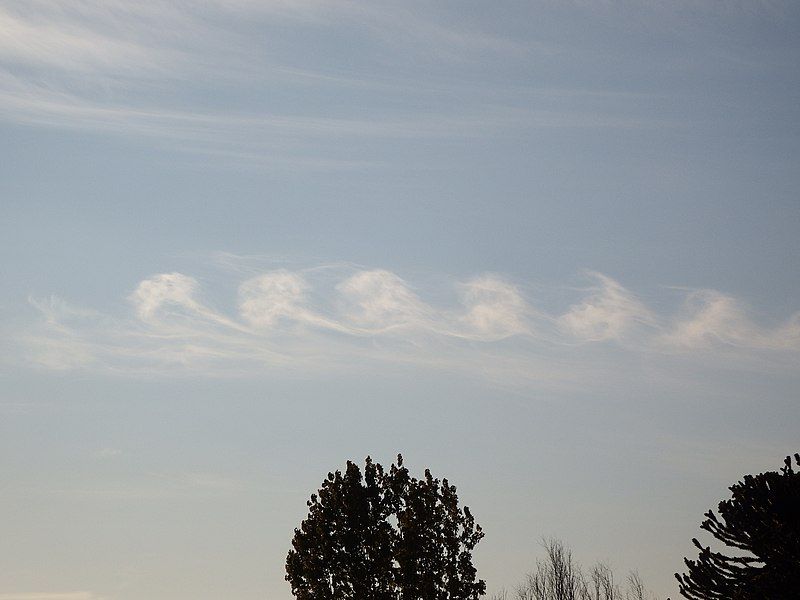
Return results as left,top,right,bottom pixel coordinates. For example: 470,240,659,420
0,0,663,171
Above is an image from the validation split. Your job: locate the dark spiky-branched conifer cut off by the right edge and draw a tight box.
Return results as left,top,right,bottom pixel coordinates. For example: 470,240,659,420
675,454,800,600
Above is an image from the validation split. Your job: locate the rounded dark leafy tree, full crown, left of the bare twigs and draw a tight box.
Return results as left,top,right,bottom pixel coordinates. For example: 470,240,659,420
286,455,486,600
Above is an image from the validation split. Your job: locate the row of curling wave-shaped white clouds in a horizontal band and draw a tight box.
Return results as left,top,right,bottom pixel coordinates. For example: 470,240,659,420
19,266,800,377
